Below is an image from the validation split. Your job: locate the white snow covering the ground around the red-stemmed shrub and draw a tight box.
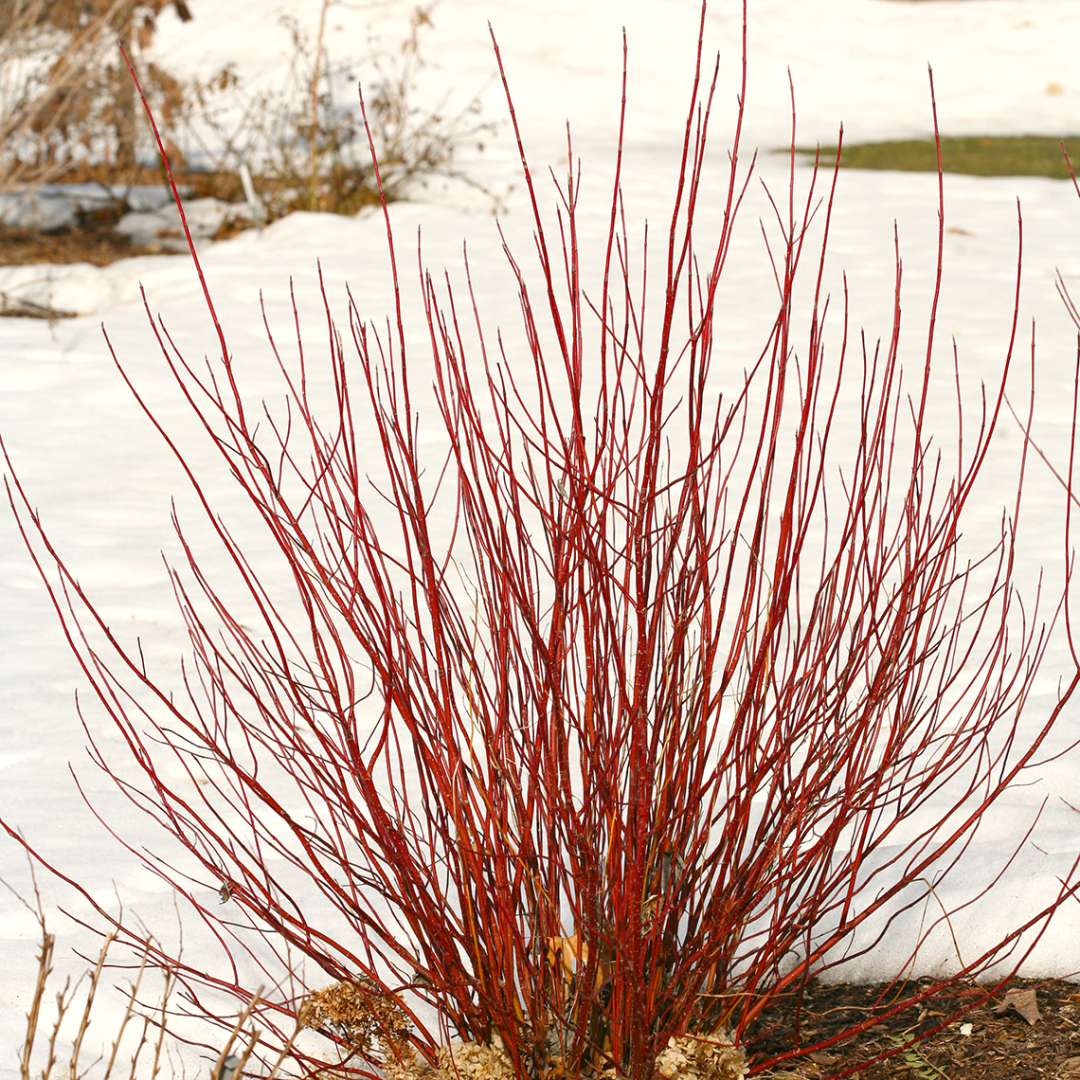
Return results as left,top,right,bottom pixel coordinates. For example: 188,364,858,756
0,0,1080,1077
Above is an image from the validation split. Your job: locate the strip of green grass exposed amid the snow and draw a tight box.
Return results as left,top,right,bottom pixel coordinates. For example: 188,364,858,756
798,135,1080,180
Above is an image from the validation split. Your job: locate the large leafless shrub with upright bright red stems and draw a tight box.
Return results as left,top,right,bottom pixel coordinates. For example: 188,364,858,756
2,6,1080,1080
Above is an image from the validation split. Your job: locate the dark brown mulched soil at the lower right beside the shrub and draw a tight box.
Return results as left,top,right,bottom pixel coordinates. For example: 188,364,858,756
754,980,1080,1080
